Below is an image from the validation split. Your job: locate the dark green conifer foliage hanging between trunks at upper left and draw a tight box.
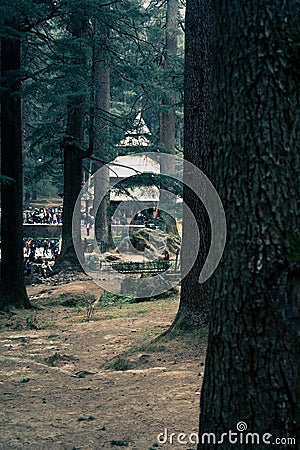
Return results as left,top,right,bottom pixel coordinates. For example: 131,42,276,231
0,0,183,206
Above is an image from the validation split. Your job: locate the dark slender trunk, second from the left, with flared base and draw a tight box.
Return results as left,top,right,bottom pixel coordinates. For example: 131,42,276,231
55,9,89,270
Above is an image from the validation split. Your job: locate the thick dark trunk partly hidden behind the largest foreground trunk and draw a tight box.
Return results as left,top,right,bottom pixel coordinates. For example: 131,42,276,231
172,1,211,327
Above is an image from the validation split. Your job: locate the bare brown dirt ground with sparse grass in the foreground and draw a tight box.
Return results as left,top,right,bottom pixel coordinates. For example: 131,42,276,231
0,275,206,450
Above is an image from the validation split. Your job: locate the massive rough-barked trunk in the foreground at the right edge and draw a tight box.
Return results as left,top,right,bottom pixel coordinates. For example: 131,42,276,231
198,0,300,444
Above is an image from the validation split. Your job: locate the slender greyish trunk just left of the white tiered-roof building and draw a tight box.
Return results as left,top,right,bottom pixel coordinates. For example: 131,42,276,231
94,24,113,249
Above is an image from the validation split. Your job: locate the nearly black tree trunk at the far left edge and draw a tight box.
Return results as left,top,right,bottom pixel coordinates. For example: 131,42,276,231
0,33,30,310
